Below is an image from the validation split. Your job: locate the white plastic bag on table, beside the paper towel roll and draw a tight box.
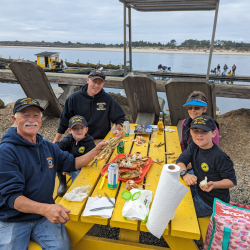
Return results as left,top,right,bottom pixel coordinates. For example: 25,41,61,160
122,188,153,222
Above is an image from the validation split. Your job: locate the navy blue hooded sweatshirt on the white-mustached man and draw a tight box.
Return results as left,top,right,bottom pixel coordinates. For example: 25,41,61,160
0,128,76,222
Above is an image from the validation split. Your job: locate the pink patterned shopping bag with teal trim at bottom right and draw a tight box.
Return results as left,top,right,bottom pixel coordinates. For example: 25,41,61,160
204,199,250,250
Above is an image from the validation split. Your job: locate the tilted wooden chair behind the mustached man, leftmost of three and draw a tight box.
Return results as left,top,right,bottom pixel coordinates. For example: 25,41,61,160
9,60,62,117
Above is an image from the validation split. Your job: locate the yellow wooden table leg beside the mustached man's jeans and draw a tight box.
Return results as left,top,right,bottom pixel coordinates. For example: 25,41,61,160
65,221,94,247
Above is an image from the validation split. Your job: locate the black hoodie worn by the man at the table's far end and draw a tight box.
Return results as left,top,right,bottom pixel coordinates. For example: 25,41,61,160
57,84,125,139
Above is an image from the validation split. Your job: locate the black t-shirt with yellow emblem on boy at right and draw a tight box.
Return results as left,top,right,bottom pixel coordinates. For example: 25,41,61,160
176,142,237,207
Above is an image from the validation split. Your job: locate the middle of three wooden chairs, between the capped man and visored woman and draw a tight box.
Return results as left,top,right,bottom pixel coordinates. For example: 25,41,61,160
123,72,165,124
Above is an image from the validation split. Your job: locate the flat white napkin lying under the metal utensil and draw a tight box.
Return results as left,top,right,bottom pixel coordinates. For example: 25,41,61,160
82,196,115,218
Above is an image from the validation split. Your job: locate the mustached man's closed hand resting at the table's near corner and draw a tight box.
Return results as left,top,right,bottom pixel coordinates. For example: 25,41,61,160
43,204,70,224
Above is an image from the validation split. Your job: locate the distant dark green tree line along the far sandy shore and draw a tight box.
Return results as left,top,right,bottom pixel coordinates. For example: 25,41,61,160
0,39,250,50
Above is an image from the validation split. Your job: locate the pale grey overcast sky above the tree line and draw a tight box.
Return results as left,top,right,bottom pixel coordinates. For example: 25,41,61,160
0,0,250,44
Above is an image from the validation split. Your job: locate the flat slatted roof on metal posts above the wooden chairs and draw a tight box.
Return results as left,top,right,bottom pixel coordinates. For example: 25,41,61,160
119,0,219,12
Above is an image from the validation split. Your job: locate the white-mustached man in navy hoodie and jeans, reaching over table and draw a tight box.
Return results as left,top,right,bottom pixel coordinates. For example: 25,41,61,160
0,98,106,249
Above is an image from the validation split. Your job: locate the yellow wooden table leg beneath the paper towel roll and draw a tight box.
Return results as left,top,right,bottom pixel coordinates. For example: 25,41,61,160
163,235,199,250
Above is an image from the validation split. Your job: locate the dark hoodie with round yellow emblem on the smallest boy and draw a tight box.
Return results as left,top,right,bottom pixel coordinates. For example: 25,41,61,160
56,134,95,157
